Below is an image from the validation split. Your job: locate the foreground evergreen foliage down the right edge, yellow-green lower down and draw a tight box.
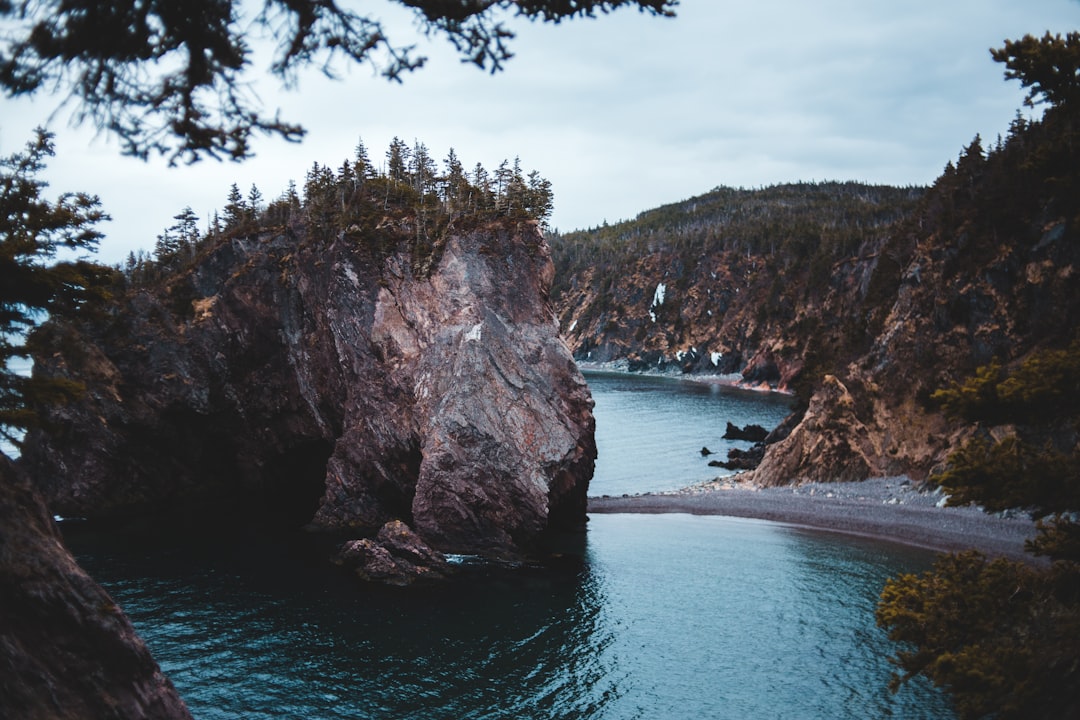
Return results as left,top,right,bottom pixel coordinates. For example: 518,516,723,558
877,32,1080,719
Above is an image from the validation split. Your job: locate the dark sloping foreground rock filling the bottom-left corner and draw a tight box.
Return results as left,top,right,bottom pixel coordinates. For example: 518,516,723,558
0,456,191,720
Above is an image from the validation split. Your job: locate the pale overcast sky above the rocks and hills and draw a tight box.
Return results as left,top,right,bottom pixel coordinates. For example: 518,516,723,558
0,0,1080,262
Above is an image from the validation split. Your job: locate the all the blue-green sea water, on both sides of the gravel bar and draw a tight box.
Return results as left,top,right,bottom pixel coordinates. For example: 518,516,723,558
67,376,953,720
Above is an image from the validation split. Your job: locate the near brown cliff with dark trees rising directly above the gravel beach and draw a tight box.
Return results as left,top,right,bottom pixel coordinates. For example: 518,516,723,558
756,124,1080,483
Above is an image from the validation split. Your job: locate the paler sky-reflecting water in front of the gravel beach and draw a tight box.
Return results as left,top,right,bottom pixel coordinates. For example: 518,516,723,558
590,515,953,719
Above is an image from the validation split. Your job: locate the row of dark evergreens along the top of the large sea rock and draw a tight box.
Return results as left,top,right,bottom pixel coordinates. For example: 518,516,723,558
120,137,554,282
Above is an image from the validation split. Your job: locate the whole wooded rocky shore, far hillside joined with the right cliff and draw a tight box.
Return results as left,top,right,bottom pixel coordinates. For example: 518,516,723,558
555,110,1080,485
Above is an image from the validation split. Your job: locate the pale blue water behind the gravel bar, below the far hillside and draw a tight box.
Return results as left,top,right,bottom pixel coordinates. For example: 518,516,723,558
585,372,792,495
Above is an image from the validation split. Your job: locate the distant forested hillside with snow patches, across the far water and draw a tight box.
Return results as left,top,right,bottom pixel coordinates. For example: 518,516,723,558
550,182,922,395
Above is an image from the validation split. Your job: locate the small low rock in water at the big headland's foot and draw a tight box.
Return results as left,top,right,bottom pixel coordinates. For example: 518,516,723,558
334,520,450,586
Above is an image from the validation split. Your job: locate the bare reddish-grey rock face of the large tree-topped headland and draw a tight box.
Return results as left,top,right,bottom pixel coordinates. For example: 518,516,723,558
24,221,595,555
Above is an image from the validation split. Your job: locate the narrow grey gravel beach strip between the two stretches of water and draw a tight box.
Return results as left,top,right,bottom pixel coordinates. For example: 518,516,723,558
589,477,1035,560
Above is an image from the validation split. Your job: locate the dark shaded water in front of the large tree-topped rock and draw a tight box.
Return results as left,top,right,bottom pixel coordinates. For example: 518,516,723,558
68,528,619,718
